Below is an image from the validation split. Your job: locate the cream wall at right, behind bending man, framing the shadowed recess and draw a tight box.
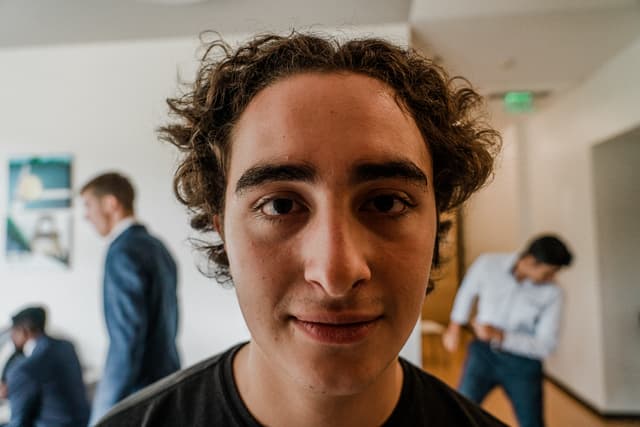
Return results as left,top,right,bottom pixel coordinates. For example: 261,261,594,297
526,35,640,412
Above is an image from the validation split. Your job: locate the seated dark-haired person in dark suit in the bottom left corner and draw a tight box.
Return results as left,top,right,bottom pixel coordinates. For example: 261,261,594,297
7,307,89,427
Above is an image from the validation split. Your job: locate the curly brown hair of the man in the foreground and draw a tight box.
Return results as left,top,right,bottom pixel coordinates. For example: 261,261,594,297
159,32,501,288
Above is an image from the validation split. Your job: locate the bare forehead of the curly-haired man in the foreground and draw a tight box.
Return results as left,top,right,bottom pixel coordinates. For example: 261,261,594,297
229,73,431,182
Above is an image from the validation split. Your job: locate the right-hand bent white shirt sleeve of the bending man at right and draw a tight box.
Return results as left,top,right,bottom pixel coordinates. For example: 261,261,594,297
500,292,564,359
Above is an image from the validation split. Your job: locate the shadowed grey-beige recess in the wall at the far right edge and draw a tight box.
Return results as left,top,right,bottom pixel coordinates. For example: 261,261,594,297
592,132,640,411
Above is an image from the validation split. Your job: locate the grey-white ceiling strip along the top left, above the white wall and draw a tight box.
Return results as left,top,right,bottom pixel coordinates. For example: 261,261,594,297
0,0,411,48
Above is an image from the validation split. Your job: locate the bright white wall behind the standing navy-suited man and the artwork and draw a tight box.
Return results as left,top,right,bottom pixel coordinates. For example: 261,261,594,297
0,24,420,378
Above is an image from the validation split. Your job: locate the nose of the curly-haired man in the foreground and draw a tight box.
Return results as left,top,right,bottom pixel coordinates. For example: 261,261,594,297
303,207,371,297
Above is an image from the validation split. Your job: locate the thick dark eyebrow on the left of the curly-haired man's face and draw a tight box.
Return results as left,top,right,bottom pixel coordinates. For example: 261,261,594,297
236,164,318,194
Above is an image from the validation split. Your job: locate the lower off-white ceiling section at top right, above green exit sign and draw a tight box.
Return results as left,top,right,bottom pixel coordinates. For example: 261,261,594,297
410,0,640,127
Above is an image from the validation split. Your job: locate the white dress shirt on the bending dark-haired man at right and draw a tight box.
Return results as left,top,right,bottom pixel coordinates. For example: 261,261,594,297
451,254,563,359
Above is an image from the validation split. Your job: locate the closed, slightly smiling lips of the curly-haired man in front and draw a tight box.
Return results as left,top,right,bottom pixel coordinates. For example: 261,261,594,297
292,316,382,345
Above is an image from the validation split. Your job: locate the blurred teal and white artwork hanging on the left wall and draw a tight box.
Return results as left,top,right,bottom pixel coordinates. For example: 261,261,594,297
6,155,73,271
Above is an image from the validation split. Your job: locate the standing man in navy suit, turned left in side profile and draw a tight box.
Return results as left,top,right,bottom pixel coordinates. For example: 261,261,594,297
80,173,180,425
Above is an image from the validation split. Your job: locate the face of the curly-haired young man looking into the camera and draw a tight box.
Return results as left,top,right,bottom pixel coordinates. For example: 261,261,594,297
218,73,436,395
